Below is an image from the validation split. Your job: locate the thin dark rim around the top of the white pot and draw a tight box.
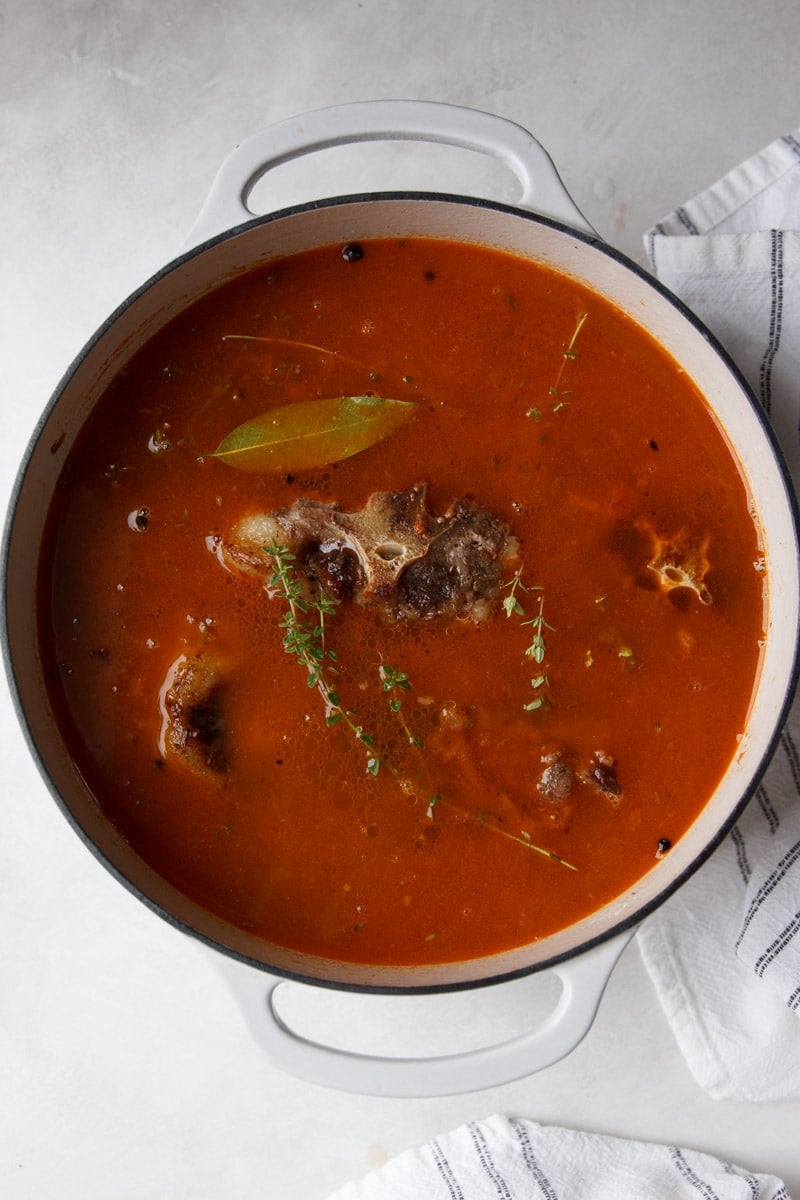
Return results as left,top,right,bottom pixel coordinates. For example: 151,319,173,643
0,190,800,995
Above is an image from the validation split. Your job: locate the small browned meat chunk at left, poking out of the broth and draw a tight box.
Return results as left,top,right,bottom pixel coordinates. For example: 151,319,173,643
161,653,228,774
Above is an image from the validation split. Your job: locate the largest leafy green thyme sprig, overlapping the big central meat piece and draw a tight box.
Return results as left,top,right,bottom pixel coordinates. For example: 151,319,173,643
264,541,380,775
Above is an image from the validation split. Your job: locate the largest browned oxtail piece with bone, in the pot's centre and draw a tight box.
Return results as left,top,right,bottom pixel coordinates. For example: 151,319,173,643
213,485,517,620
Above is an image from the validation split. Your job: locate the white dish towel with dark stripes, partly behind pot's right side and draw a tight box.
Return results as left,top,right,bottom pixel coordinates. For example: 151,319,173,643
638,130,800,1100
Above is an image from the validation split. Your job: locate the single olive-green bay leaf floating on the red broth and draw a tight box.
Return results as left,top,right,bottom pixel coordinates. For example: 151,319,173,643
213,396,416,473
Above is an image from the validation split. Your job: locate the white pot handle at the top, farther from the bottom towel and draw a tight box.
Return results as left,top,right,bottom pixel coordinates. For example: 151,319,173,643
185,100,595,250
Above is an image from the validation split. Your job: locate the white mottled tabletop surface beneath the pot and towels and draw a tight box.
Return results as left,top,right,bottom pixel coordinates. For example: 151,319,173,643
0,0,800,1200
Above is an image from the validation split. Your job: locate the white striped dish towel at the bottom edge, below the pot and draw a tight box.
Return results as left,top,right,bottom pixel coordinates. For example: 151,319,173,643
329,1116,789,1200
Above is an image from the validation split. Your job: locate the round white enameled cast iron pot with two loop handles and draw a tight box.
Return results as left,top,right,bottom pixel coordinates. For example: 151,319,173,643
4,101,799,1096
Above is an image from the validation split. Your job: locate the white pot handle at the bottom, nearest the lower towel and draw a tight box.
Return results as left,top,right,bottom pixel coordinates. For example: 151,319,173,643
212,929,634,1098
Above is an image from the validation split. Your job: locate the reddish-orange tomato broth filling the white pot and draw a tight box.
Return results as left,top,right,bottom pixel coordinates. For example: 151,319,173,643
41,240,765,964
